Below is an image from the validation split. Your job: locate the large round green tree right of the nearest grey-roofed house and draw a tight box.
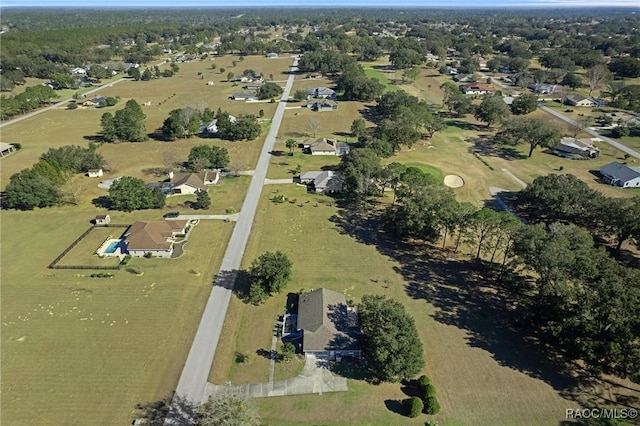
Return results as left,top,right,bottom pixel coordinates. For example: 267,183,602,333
358,295,424,383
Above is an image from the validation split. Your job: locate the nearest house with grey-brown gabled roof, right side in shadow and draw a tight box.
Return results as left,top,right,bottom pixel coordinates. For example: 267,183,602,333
296,288,362,361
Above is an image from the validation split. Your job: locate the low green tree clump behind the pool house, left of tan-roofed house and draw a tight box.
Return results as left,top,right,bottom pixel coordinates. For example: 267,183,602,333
109,176,166,212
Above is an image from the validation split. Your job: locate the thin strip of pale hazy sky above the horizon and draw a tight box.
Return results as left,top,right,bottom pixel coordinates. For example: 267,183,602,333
0,0,640,9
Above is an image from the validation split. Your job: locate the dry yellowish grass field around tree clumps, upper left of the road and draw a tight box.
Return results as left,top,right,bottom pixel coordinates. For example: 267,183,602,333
0,52,292,186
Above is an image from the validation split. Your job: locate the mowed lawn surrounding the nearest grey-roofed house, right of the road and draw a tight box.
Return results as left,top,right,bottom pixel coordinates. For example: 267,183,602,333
210,185,573,425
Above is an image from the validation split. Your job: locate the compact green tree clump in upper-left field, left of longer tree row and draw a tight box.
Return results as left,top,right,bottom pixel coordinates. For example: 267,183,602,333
100,99,149,142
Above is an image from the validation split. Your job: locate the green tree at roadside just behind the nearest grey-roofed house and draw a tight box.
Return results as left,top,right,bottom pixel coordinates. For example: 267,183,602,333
247,250,292,305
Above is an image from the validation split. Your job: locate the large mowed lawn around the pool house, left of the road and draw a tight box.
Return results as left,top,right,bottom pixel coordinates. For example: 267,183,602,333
1,208,233,425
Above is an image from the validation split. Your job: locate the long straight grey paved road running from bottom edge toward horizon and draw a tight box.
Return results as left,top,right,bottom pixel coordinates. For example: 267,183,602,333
165,58,298,426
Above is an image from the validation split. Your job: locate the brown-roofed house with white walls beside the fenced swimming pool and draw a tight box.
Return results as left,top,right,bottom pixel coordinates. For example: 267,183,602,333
124,220,189,258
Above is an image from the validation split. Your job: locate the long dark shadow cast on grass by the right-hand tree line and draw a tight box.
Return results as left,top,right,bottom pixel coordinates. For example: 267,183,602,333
331,209,640,407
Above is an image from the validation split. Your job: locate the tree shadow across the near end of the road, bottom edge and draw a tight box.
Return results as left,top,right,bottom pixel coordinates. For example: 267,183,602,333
135,396,197,426
